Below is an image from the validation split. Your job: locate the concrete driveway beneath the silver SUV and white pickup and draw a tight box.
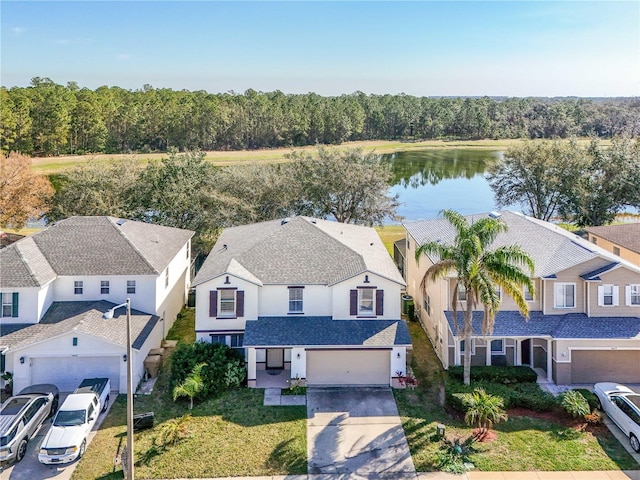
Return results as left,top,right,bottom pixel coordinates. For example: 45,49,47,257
0,392,118,480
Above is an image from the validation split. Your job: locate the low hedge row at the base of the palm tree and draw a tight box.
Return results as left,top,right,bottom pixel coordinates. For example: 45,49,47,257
445,380,558,412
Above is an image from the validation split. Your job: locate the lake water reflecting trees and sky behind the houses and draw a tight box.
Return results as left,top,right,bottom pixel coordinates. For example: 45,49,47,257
383,150,510,220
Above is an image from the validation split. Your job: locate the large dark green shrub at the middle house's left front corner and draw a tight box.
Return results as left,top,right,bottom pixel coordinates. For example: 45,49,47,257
171,342,246,398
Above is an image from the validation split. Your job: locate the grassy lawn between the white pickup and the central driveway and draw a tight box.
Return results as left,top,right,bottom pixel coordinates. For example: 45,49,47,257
72,315,307,479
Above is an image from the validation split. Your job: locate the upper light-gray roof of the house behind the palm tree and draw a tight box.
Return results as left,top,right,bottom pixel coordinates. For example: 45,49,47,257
403,211,640,278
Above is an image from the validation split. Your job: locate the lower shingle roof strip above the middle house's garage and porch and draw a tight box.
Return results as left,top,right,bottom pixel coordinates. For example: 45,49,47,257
244,317,411,347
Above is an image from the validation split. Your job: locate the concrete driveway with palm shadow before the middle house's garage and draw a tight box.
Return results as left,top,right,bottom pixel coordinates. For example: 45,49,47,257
307,387,416,478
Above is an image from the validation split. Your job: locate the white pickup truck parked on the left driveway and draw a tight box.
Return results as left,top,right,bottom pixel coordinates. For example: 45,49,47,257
38,378,111,465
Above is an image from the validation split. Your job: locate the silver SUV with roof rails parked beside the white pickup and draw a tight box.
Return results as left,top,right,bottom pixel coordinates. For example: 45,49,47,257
0,385,59,462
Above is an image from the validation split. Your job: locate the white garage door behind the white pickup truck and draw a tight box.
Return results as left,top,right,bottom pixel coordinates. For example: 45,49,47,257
31,356,124,392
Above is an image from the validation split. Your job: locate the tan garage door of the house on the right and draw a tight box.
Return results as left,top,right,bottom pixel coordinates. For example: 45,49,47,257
571,350,640,383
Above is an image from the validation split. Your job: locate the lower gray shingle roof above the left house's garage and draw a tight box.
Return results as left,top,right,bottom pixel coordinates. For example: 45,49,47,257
0,300,159,350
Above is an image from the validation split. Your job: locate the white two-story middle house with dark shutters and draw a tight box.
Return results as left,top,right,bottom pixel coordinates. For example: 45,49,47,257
193,217,411,387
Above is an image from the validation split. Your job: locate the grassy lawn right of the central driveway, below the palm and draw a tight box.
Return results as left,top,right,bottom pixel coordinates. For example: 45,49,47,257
394,322,638,471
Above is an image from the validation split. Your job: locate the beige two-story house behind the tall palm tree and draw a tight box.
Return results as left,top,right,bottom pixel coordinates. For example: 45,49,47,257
404,212,640,385
